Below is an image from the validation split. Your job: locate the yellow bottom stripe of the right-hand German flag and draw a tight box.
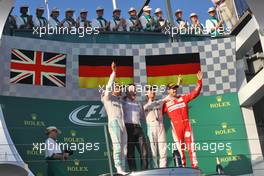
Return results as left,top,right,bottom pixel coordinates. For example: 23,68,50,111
147,74,198,86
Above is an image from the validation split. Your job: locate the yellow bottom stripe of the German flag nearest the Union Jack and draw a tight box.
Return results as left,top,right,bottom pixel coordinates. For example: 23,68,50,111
79,77,134,88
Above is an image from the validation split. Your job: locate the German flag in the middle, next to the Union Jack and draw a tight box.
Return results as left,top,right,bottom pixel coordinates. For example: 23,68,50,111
79,55,133,88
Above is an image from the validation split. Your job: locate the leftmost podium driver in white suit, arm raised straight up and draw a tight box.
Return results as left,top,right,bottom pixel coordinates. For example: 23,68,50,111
101,62,127,175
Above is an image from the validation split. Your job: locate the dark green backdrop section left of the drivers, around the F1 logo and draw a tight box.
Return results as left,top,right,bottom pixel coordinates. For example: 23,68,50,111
0,97,109,176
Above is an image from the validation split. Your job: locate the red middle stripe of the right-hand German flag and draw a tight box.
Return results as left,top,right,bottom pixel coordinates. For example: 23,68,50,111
147,63,201,76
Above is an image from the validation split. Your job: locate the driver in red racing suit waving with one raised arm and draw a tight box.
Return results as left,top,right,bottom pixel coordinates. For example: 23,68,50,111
163,71,203,168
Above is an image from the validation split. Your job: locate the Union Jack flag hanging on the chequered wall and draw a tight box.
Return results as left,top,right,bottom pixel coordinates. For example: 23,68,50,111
10,49,66,87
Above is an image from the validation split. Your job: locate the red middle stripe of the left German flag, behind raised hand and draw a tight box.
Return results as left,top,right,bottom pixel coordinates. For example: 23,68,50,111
79,65,133,77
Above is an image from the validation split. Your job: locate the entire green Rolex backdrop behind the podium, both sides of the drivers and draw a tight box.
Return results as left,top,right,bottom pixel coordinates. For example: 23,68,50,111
0,93,252,176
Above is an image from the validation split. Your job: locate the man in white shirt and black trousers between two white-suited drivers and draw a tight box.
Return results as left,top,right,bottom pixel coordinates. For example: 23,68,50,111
123,84,148,171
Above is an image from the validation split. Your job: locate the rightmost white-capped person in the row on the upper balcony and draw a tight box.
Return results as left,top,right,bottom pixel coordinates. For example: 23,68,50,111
205,7,225,37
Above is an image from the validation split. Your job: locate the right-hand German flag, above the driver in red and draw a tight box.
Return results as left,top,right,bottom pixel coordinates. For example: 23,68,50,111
146,53,201,85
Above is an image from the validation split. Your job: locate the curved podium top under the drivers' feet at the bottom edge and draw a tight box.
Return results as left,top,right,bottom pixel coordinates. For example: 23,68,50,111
99,167,202,176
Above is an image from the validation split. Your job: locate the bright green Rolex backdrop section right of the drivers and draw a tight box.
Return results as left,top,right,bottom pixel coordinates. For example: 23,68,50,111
165,93,252,175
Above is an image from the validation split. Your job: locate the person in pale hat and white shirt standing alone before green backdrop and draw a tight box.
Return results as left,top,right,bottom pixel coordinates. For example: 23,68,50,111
45,126,69,176
